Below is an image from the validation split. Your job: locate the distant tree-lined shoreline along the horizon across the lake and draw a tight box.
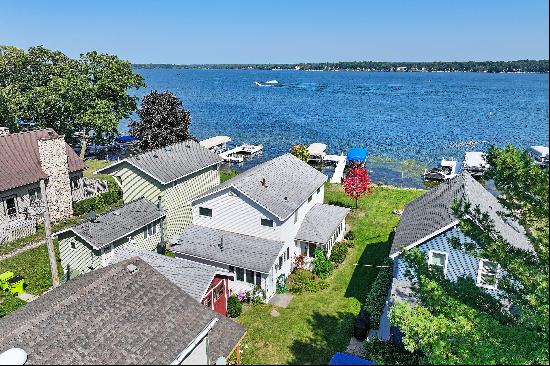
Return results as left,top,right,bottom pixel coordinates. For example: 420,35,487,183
132,60,549,74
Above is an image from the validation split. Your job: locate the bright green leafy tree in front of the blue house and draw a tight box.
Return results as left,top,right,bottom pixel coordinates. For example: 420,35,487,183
390,146,549,364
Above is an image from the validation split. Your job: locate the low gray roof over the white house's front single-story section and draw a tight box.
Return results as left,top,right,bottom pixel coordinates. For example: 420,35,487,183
172,225,285,273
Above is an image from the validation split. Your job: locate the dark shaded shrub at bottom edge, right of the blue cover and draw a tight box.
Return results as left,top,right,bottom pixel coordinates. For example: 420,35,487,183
363,338,425,365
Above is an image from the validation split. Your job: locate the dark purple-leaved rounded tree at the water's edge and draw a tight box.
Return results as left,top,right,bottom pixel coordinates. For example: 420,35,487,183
130,91,195,151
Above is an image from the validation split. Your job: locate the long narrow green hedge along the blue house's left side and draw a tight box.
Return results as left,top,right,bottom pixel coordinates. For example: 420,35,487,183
364,258,393,328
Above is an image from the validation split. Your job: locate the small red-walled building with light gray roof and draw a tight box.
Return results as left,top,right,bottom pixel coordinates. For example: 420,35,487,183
109,247,231,315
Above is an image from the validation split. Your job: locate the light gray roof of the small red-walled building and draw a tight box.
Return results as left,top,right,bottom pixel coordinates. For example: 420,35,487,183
110,247,226,302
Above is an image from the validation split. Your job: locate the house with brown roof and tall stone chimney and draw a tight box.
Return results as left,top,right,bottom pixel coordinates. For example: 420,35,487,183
0,129,86,243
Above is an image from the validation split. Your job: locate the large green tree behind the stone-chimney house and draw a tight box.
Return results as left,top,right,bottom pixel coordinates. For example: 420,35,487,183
0,46,145,156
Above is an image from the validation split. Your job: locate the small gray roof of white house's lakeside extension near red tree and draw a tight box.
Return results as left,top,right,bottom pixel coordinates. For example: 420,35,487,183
296,203,349,244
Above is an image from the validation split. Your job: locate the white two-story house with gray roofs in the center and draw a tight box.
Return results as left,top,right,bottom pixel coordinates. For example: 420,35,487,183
172,154,349,299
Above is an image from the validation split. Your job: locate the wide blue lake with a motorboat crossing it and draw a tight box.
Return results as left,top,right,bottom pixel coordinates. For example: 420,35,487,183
120,69,549,187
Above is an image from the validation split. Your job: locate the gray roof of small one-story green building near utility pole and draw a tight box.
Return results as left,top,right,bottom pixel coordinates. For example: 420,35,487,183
57,198,165,249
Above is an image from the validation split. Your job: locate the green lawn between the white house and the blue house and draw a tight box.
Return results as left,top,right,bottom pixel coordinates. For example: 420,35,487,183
237,184,423,365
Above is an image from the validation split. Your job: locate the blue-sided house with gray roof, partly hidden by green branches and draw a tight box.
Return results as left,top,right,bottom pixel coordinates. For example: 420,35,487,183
379,173,533,339
